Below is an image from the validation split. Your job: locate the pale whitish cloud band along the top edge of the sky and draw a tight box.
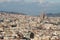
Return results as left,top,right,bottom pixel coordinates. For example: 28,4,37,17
0,0,60,3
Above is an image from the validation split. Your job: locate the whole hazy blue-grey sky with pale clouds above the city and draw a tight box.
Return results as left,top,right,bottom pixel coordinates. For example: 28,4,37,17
0,0,60,14
